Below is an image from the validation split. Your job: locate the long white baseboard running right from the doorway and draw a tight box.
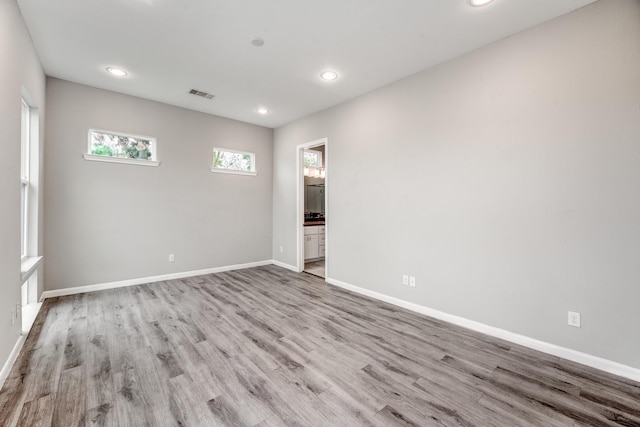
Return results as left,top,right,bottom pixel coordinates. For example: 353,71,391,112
326,278,640,381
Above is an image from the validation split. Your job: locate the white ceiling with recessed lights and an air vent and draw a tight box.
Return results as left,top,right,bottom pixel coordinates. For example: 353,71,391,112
18,0,595,127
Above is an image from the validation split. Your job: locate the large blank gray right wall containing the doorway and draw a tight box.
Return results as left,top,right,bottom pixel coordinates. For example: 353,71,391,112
273,0,640,368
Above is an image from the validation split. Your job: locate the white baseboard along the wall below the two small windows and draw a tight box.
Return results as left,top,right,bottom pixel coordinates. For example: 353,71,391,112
40,260,273,301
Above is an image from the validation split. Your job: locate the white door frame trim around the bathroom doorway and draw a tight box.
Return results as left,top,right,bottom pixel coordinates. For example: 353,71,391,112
296,138,331,279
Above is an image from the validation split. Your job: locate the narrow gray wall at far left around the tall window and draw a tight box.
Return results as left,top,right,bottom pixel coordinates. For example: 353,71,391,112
0,0,45,361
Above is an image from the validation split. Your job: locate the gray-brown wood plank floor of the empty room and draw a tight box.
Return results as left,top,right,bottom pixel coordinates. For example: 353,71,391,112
0,266,640,427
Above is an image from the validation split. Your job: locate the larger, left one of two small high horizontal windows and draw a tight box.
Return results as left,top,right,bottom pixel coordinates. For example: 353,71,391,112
84,129,160,166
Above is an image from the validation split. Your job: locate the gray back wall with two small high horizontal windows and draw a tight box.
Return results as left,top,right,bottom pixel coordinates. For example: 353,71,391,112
45,78,273,289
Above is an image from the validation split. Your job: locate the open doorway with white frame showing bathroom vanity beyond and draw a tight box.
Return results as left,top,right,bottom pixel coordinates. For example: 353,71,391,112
296,138,329,278
